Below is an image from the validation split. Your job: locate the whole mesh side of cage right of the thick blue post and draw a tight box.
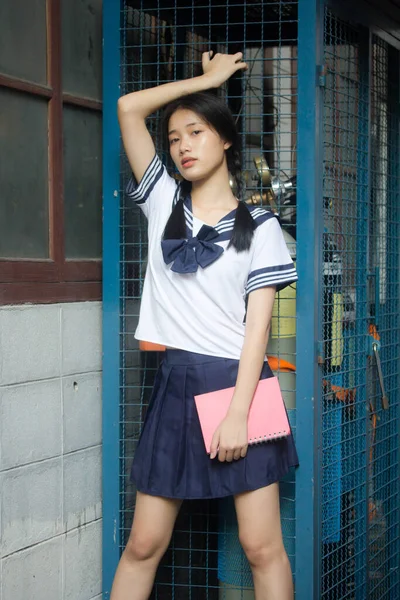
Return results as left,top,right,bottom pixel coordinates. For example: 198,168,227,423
319,10,400,600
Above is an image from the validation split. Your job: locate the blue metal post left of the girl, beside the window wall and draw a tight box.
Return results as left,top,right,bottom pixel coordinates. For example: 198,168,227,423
103,0,120,600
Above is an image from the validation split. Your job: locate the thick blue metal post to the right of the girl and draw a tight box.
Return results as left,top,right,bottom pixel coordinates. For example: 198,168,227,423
296,0,323,600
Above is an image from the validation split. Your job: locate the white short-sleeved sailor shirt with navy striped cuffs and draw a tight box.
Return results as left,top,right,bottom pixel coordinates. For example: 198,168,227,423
126,155,297,359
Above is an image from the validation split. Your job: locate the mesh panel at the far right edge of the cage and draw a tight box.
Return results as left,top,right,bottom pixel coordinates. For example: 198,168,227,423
368,36,400,600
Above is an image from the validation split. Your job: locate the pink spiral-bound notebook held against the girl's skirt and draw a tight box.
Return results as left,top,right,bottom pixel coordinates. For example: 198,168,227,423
194,377,290,453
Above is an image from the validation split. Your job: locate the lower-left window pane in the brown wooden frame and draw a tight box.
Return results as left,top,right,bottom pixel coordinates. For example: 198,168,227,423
0,88,49,258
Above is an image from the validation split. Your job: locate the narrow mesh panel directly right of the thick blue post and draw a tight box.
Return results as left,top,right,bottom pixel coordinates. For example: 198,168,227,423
320,10,369,599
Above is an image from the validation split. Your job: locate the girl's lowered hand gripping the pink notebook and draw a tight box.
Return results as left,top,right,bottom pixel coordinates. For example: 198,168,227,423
210,413,248,462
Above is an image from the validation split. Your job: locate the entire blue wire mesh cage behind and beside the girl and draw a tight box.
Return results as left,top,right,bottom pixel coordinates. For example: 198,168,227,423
105,0,400,600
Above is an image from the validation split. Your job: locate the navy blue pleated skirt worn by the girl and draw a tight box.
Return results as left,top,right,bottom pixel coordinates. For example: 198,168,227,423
131,350,298,499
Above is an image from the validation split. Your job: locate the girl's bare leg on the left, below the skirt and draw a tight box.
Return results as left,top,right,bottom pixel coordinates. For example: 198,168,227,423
110,492,182,600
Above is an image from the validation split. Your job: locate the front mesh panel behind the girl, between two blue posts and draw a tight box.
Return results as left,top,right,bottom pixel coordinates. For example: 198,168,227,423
120,0,297,600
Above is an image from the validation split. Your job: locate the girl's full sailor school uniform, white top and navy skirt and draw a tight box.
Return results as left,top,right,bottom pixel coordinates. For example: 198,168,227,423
126,156,298,499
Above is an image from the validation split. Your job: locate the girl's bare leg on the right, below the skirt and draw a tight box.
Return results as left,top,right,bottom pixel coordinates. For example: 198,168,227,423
235,483,293,600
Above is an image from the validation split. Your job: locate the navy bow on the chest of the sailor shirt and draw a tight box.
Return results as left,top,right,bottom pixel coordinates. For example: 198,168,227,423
161,225,224,273
